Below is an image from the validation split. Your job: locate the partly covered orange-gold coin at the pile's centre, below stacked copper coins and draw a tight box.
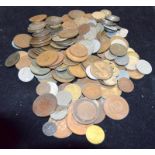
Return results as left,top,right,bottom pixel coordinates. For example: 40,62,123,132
68,64,87,78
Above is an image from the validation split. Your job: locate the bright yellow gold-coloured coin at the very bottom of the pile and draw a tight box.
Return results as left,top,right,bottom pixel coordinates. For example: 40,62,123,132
86,125,105,144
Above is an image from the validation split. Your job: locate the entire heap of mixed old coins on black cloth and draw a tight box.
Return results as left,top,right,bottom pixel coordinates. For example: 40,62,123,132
5,9,152,144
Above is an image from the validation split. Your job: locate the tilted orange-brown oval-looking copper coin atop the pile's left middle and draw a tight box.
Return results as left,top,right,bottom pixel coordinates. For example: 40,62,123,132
36,51,58,67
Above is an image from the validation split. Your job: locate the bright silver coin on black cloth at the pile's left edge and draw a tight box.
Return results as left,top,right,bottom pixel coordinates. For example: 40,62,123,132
18,67,34,82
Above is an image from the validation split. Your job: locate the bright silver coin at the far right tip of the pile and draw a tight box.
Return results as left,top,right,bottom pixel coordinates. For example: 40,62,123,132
136,59,152,74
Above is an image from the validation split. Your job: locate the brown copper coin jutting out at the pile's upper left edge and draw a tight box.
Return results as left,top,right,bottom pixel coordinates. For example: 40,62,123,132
13,34,32,48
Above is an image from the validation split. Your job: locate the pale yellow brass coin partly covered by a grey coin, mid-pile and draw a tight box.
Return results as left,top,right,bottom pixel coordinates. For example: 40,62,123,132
64,84,81,100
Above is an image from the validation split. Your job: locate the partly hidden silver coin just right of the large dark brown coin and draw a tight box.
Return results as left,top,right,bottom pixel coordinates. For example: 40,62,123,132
50,106,68,121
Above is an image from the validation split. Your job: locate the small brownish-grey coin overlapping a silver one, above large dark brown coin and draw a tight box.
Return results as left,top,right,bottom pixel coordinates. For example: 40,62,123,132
36,82,50,95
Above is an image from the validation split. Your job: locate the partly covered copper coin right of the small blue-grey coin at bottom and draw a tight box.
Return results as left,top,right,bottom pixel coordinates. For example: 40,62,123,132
54,118,72,138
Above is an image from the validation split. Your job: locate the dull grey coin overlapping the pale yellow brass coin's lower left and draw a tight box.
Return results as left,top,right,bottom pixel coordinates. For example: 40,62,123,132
56,89,72,106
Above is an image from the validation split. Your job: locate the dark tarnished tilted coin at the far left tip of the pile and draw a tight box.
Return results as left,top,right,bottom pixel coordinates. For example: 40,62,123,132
5,52,20,67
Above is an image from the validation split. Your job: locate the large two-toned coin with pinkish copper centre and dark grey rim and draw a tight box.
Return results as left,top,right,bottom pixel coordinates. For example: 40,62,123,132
73,98,99,124
